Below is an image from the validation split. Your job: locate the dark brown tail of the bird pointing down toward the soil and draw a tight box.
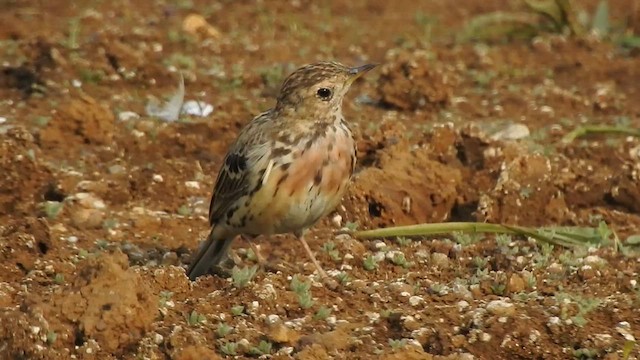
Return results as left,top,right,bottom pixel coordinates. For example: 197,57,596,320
187,226,234,281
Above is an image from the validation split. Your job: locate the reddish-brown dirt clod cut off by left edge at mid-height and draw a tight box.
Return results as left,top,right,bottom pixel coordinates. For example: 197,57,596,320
0,127,52,216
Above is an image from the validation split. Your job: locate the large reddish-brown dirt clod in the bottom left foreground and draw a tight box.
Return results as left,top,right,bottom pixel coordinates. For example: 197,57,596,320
50,253,158,352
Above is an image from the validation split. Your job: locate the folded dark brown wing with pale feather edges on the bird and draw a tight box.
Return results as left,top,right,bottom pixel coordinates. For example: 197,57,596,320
209,112,270,225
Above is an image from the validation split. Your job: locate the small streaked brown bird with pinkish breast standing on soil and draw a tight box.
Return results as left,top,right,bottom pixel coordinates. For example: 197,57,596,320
187,62,376,280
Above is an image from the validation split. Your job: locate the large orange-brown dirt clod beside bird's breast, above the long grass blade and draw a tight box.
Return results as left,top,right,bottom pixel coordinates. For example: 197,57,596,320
344,143,462,227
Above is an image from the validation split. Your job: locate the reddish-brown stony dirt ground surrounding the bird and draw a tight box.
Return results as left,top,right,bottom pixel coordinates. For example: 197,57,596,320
0,0,640,360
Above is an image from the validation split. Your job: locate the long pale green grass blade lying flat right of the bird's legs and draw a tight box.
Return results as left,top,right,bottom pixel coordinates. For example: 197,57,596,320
352,222,609,247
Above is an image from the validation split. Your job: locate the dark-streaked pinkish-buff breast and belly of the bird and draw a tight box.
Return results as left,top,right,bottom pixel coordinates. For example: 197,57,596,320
245,125,356,233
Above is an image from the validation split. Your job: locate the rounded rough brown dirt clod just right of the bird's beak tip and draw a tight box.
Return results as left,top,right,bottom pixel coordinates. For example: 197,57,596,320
378,51,455,110
